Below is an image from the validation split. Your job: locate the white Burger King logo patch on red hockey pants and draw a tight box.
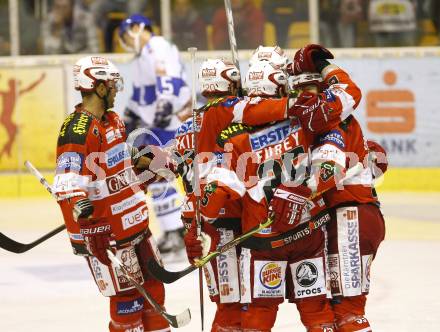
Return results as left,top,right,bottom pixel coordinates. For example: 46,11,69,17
254,261,287,298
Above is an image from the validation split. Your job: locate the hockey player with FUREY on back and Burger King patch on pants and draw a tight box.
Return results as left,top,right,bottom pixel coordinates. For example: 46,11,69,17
198,62,334,331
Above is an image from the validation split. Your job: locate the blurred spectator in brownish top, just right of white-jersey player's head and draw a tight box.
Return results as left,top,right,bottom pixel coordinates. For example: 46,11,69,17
171,0,207,50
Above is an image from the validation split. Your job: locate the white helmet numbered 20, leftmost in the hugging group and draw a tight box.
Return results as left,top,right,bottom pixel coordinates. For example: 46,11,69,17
199,59,240,97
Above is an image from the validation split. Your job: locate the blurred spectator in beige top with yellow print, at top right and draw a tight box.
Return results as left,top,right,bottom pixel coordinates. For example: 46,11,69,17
368,0,417,47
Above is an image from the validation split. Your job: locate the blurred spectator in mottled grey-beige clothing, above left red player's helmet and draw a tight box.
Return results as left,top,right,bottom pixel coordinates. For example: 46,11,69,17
41,0,99,54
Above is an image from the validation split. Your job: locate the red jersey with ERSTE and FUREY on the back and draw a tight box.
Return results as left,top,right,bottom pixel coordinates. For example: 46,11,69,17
202,120,325,237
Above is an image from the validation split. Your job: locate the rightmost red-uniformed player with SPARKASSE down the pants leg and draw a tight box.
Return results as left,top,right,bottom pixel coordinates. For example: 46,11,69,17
280,45,386,332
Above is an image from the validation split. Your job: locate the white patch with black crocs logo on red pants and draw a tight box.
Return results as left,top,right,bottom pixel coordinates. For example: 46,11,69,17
290,258,326,299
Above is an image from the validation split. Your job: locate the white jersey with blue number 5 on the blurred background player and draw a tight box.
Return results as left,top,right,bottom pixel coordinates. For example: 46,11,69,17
128,35,191,130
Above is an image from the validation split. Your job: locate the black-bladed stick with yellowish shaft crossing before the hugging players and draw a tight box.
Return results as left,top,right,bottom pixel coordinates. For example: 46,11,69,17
147,218,273,284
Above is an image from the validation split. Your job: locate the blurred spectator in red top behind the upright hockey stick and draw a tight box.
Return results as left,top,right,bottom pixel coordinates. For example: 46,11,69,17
212,0,265,50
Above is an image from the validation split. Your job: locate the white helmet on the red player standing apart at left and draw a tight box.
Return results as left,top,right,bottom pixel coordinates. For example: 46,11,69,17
73,56,124,92
